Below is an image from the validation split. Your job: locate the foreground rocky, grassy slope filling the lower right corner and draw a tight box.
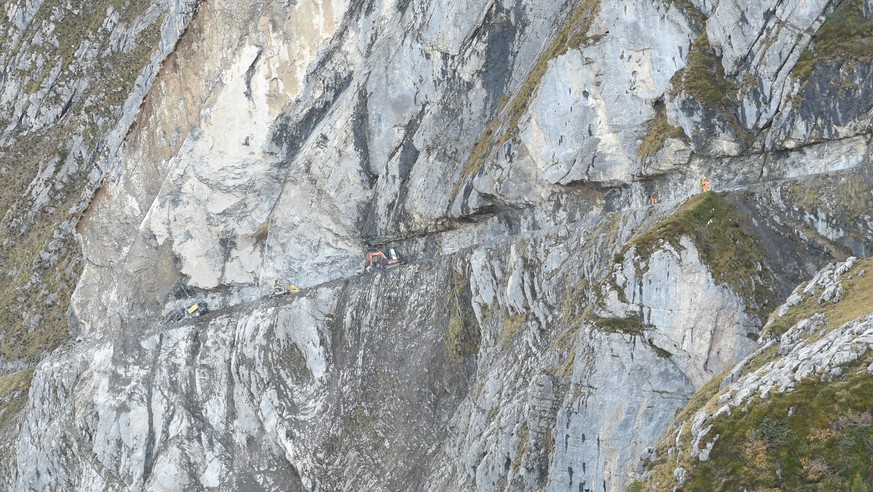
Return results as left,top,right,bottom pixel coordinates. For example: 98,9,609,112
643,257,873,490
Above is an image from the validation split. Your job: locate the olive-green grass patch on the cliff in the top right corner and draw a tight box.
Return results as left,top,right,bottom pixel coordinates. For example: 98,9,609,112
793,0,873,78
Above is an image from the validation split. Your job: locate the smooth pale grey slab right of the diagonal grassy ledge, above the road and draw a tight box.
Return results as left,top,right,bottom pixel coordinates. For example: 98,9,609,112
521,2,691,184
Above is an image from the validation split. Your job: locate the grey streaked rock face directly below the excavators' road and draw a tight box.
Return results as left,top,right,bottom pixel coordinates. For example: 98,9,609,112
8,206,788,490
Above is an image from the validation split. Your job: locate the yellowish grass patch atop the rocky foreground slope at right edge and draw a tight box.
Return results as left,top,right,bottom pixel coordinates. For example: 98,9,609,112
763,259,873,337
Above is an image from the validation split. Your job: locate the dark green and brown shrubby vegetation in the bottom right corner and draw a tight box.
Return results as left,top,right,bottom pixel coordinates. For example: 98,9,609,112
664,374,873,491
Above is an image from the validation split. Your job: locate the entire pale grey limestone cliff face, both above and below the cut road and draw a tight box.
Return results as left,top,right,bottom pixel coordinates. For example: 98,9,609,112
0,0,873,490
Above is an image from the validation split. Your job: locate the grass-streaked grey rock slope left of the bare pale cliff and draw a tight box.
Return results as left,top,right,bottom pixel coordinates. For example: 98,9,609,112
0,1,197,370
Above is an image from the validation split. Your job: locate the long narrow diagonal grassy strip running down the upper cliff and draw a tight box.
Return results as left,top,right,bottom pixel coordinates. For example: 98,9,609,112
459,0,600,186
